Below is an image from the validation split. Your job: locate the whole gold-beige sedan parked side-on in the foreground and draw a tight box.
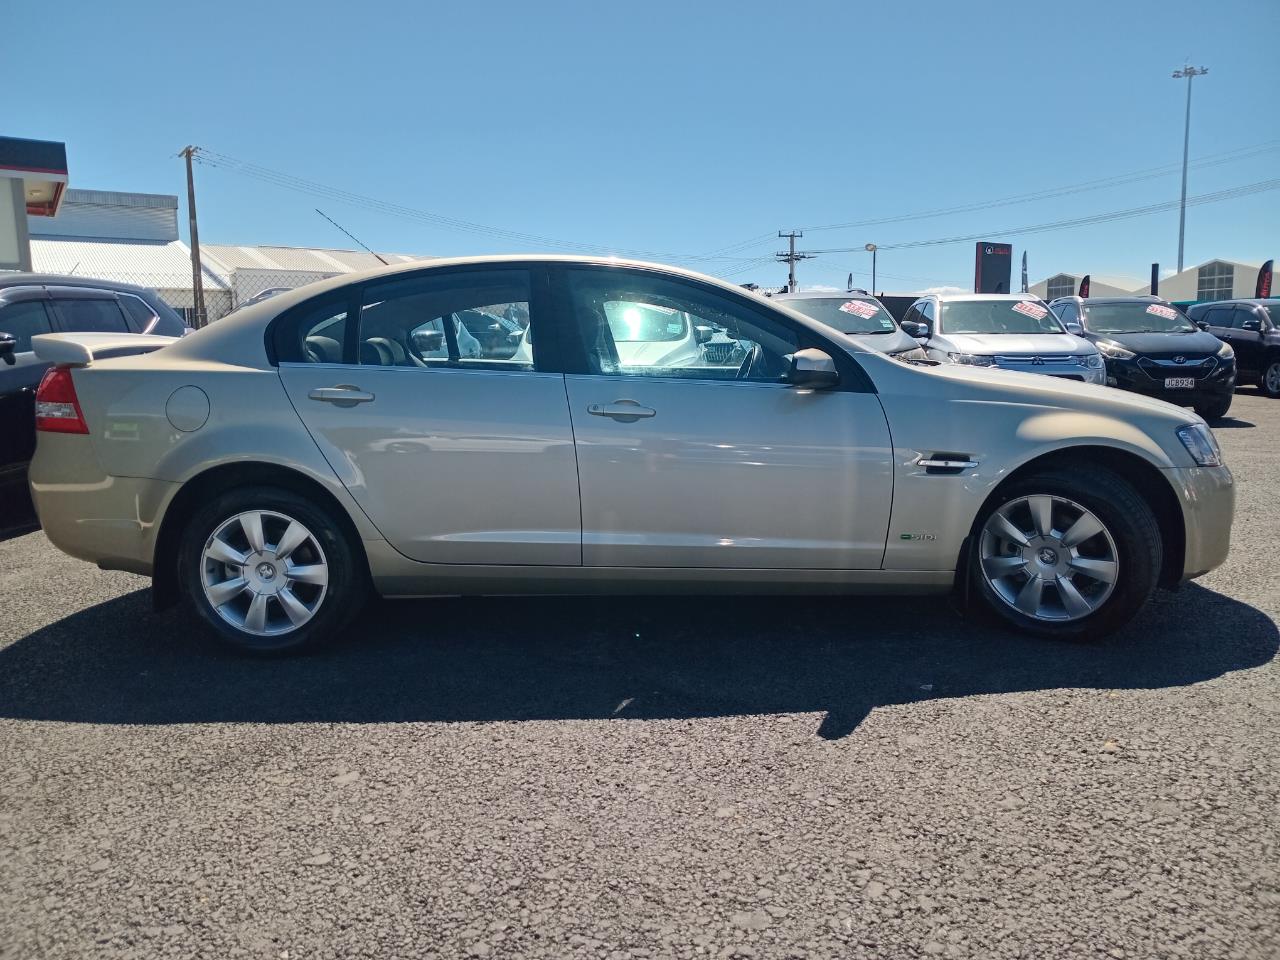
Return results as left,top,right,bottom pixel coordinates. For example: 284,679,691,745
31,257,1234,650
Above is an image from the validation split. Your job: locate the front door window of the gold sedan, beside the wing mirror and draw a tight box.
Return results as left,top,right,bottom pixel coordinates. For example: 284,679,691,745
567,269,800,383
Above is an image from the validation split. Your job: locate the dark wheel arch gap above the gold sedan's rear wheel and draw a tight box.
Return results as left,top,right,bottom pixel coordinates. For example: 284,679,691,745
151,461,369,609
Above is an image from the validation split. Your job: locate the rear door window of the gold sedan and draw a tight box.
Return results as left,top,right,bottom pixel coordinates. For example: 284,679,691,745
358,270,534,370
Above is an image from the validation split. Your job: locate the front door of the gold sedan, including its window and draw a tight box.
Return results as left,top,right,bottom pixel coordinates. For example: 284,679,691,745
562,266,892,570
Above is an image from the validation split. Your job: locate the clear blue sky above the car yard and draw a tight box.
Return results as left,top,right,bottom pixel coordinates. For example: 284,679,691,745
0,0,1280,291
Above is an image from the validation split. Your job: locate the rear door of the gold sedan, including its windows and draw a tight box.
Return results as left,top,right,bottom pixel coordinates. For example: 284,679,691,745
275,266,581,566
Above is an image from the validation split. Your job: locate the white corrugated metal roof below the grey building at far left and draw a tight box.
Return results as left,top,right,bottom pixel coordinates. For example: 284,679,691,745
31,237,227,289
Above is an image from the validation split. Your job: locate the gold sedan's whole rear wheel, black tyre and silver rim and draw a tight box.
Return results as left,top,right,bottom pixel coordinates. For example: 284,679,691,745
178,486,369,653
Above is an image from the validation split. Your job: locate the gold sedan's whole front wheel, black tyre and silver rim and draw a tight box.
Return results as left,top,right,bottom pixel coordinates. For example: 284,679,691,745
969,467,1164,640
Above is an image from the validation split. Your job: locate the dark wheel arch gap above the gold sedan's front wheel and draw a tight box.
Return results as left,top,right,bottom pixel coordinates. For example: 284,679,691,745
956,444,1187,599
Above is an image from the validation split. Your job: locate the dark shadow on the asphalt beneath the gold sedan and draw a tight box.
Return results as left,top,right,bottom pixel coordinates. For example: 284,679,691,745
0,586,1280,737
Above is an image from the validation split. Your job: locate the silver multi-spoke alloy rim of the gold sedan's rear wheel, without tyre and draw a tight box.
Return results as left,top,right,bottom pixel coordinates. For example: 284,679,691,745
200,509,329,636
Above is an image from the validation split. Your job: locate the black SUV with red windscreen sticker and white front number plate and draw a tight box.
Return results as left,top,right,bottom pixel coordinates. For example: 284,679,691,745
1050,297,1235,420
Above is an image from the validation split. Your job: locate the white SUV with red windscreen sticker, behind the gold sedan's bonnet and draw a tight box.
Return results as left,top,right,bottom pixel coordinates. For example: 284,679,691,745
902,293,1107,384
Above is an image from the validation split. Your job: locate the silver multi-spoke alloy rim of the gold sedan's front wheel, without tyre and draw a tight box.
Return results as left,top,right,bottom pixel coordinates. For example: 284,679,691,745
979,494,1120,623
